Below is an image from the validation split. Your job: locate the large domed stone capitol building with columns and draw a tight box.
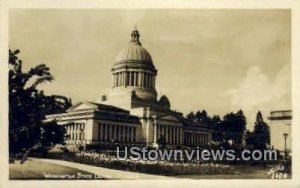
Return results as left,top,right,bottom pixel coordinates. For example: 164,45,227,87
46,29,211,147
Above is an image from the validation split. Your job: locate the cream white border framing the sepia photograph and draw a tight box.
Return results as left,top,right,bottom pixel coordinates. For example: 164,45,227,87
0,0,300,188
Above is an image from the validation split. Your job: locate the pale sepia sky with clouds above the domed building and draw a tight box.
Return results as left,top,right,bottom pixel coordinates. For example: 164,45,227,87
9,9,291,130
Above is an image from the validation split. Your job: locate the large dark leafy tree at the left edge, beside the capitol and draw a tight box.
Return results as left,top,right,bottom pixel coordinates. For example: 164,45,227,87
8,50,71,158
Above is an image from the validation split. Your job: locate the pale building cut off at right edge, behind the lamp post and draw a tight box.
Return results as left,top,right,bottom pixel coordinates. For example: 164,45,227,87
268,110,292,153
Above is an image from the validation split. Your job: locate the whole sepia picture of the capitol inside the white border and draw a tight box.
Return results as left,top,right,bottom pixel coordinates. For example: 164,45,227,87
3,5,294,182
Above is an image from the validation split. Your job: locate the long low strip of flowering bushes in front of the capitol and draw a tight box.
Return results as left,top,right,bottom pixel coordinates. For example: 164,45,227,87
42,152,234,176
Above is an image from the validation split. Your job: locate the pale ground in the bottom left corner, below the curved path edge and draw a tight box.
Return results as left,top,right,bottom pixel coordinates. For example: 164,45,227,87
9,159,103,180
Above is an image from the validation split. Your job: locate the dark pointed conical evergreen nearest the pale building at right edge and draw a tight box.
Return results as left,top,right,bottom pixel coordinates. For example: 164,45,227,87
253,111,270,150
